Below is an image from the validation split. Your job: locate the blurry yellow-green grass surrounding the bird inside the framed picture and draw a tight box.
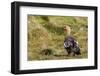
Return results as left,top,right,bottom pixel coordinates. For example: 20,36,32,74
28,15,88,61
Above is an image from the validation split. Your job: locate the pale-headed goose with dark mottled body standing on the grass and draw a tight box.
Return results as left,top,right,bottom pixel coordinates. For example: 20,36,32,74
64,25,81,56
